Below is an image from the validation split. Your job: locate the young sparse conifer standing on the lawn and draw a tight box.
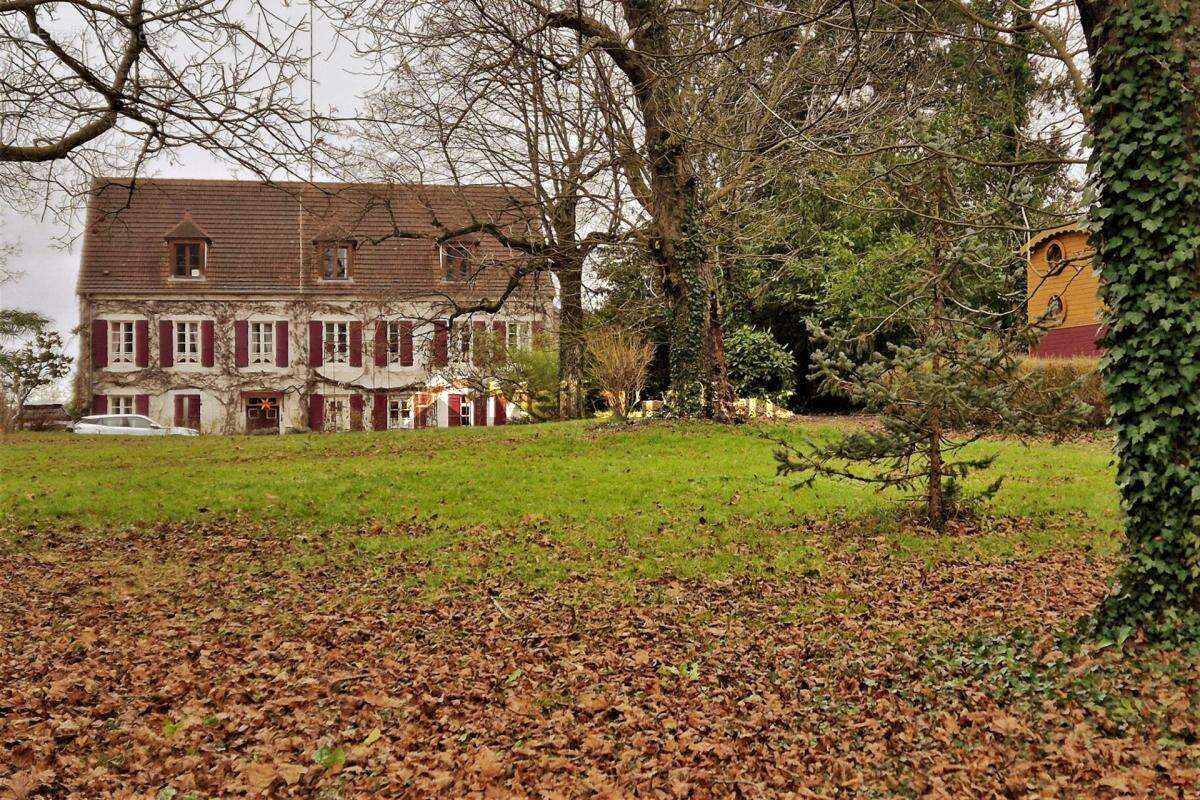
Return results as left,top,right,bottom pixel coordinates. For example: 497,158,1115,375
775,153,1085,533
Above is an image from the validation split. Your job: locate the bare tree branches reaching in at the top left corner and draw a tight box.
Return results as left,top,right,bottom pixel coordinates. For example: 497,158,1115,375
0,0,310,201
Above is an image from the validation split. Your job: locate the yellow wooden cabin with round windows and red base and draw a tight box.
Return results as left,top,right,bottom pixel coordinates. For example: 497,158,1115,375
1025,223,1104,359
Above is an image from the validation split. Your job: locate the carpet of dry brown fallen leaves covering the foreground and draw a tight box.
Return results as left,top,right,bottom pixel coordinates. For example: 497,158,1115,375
0,527,1200,800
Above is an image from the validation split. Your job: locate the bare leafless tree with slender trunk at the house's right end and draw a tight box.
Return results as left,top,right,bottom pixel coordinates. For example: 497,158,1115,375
324,0,640,417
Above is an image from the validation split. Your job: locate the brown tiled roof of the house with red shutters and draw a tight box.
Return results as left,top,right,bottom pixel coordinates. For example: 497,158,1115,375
78,178,548,299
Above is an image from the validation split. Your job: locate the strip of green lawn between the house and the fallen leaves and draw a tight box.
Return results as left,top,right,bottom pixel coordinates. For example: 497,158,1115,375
0,422,1120,583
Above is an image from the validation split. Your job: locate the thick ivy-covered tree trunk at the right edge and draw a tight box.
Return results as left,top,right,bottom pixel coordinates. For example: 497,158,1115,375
1079,0,1200,637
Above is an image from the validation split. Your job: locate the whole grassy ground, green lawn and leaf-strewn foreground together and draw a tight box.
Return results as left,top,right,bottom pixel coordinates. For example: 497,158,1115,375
9,420,1200,800
